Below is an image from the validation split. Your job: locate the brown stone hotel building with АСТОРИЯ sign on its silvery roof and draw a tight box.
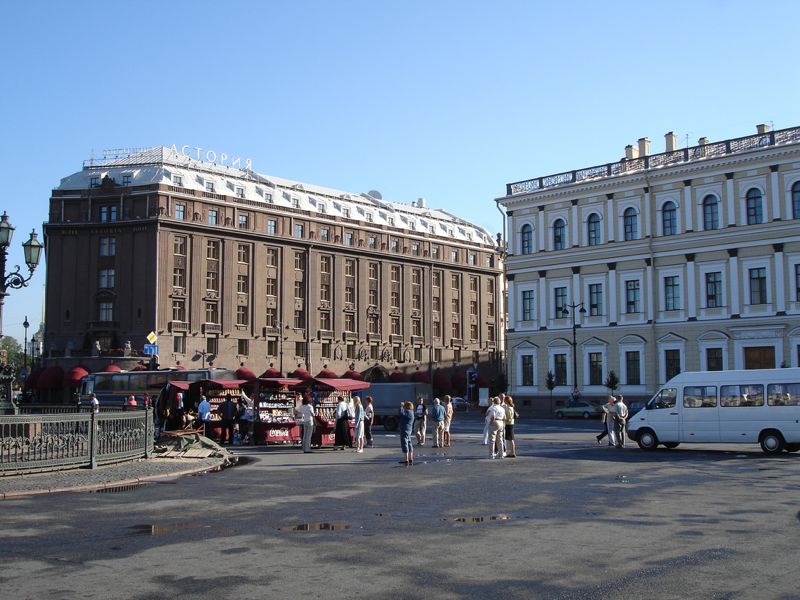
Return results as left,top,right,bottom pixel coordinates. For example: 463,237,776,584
44,147,502,386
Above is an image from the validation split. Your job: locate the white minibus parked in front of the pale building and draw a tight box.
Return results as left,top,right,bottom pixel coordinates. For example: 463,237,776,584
627,368,800,454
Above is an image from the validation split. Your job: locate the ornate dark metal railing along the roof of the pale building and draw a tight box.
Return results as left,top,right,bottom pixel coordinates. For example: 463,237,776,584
506,127,800,196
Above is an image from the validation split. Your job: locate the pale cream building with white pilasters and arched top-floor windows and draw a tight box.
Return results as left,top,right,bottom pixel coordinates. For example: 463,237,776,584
496,125,800,405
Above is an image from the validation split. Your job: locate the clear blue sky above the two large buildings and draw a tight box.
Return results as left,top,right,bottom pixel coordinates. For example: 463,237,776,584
0,0,800,340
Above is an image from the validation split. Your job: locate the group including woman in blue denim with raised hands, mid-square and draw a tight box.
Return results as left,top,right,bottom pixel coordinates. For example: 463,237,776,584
400,396,453,466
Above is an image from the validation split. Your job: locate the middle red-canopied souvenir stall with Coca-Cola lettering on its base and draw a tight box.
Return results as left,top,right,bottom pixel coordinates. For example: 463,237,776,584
251,378,302,444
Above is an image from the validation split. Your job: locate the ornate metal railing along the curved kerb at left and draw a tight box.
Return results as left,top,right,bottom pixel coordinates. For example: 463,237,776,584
0,409,154,476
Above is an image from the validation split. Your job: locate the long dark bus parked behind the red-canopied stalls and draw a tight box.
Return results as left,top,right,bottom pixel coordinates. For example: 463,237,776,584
80,369,236,406
